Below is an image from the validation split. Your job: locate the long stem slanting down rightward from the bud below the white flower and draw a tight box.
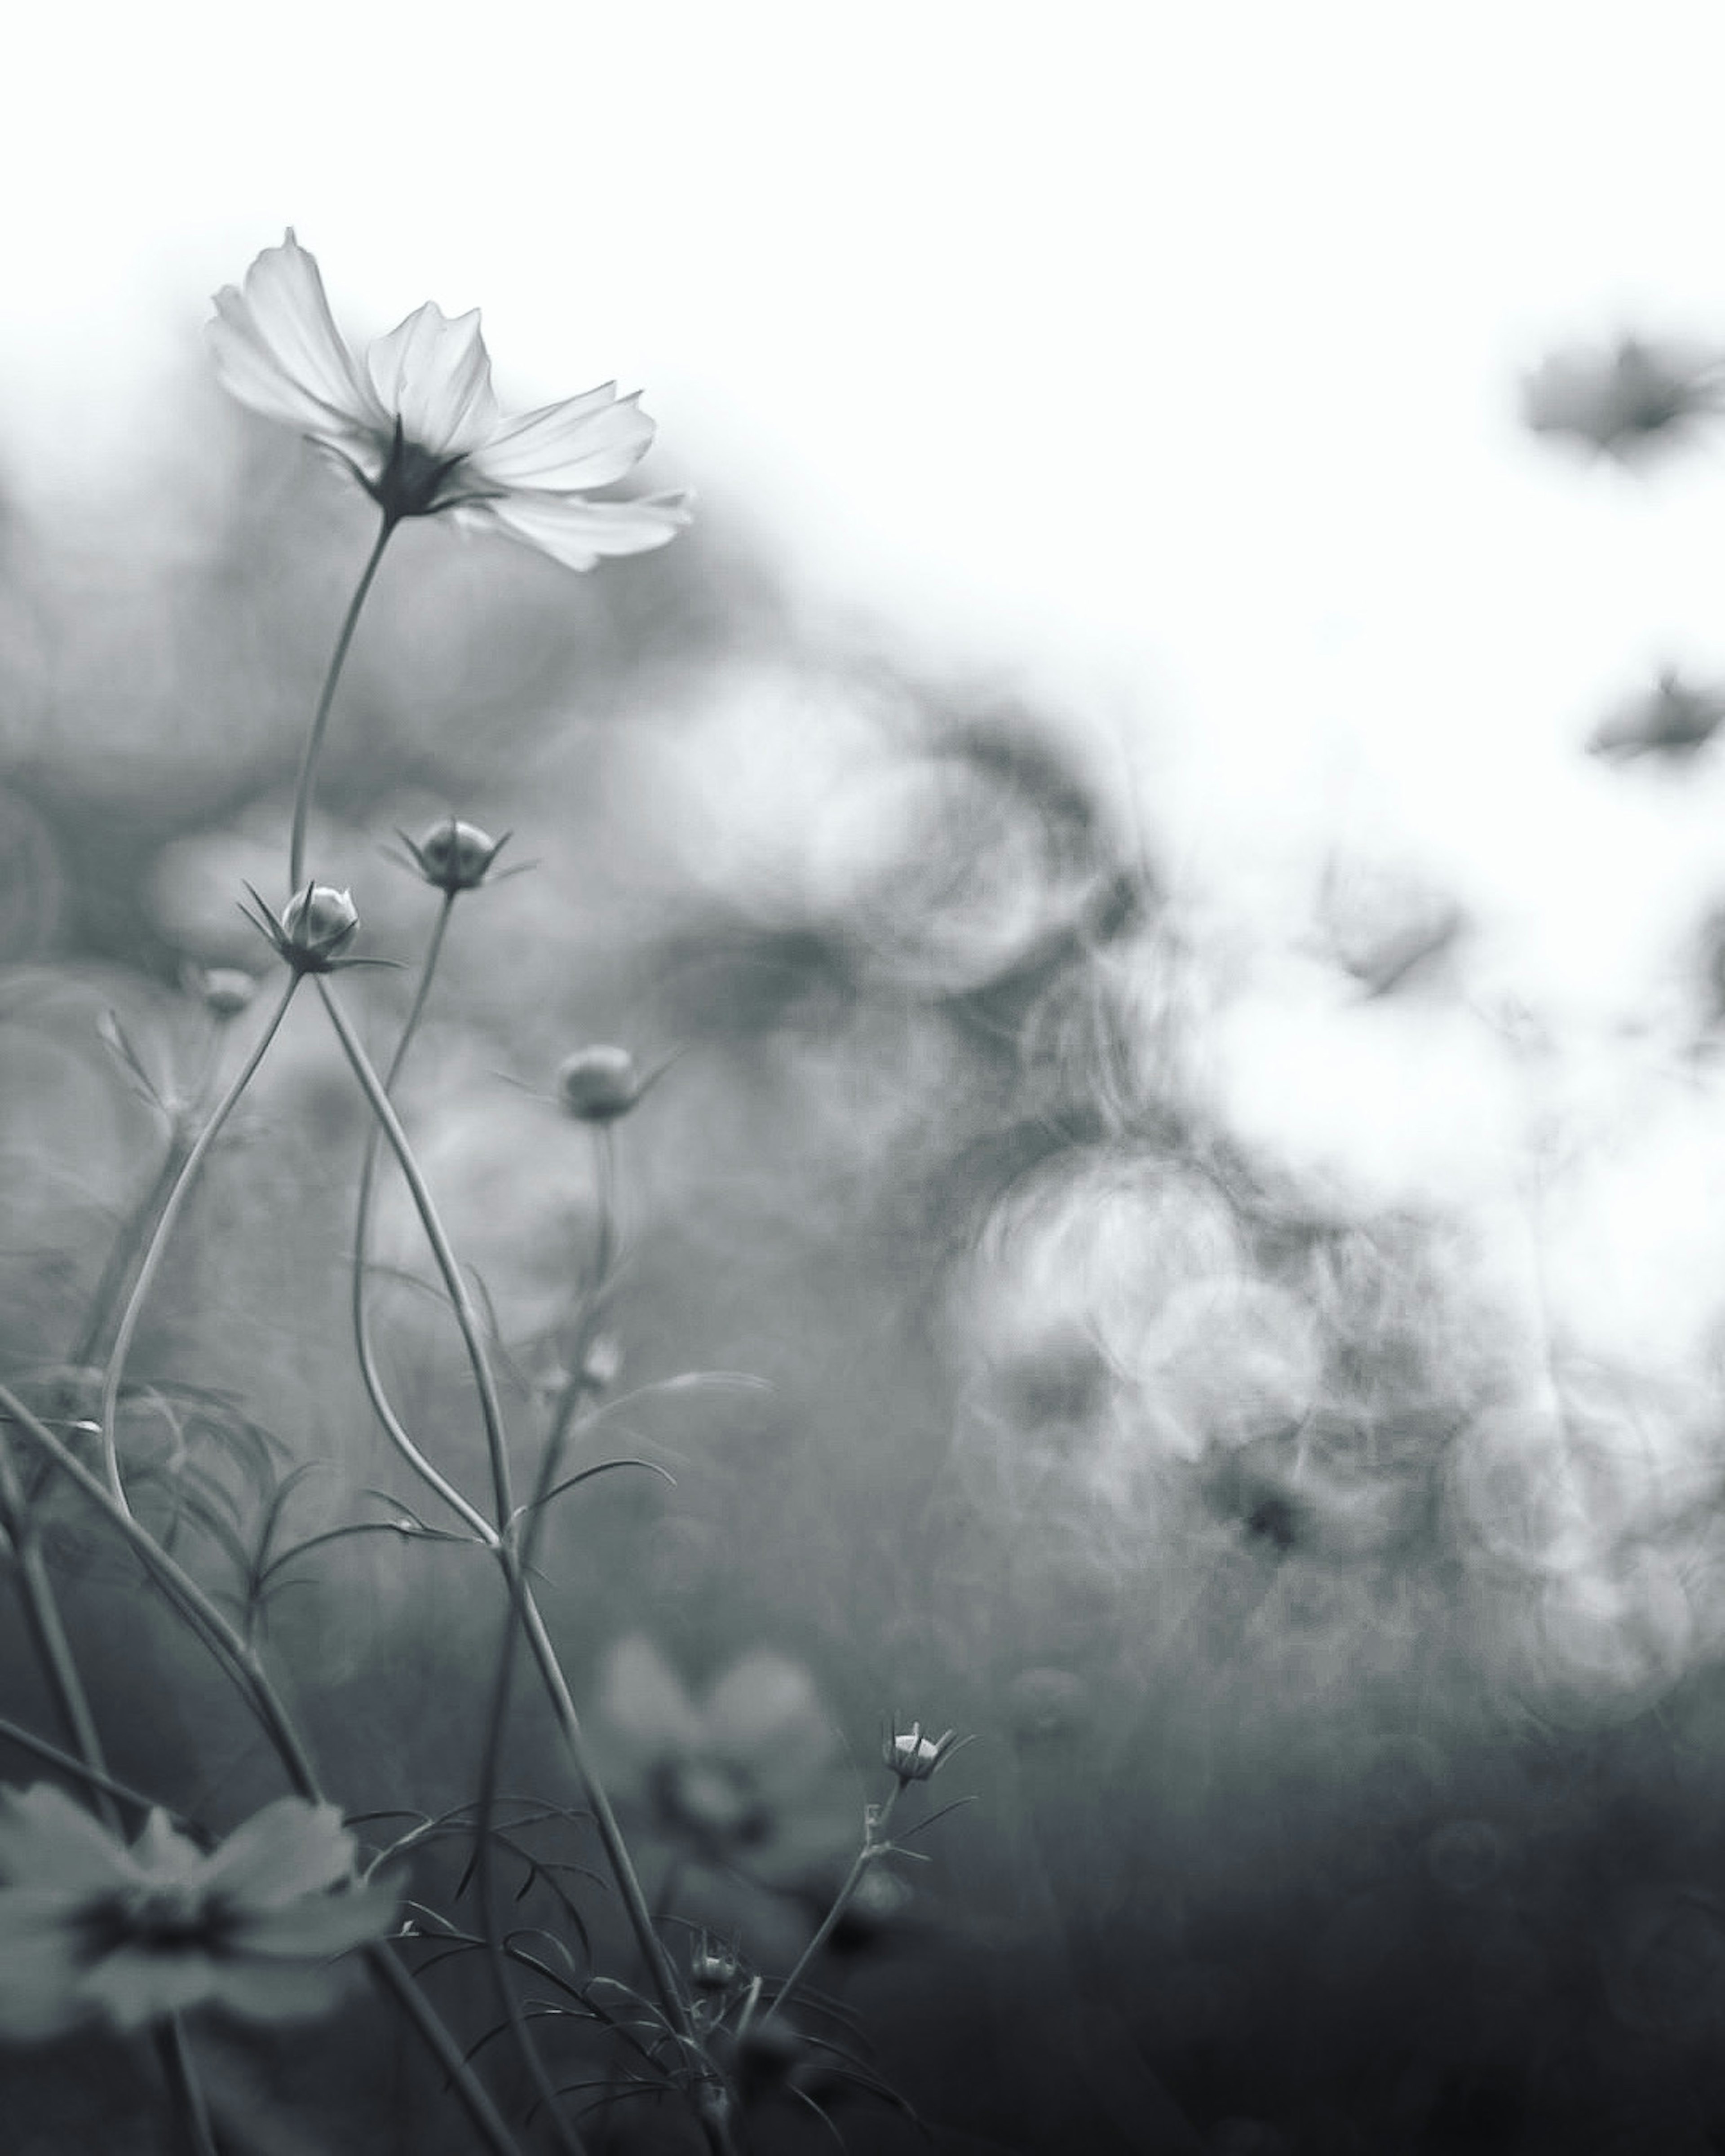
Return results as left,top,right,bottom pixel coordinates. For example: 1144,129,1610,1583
317,979,694,2042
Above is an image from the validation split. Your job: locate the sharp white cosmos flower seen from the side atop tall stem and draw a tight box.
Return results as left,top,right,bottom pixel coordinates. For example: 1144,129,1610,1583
209,231,690,569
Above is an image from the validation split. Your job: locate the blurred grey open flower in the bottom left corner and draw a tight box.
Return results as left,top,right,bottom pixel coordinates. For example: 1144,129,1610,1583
0,1783,399,2042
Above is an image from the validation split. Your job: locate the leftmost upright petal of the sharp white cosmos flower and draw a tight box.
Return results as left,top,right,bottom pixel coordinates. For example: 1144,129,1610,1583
209,229,386,436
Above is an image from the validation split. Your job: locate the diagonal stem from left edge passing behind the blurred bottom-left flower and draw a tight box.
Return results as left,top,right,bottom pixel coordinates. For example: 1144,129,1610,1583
0,1384,520,2156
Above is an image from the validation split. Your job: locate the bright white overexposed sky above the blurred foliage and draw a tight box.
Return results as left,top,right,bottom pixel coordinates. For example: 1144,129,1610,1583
17,0,1725,1362
